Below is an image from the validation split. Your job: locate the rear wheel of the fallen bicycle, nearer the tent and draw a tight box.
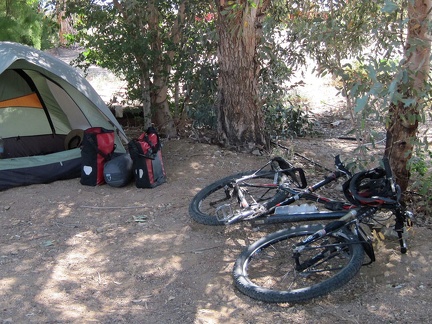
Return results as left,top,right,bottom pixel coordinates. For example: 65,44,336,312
189,171,278,225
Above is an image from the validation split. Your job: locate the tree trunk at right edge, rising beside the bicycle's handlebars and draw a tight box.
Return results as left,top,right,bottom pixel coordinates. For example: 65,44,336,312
385,0,431,191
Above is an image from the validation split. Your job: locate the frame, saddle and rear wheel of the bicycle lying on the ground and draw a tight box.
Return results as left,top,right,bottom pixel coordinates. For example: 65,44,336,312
189,156,355,225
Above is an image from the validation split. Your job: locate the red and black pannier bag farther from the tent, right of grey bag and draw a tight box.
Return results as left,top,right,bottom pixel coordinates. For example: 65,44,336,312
128,127,166,188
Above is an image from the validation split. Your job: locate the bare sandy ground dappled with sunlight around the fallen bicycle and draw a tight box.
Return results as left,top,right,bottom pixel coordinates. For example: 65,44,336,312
0,47,432,323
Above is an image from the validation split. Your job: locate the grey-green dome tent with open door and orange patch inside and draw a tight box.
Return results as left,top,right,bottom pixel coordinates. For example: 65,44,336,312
0,42,128,190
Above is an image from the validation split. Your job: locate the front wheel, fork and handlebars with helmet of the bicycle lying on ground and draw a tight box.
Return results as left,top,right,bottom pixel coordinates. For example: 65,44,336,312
233,158,412,303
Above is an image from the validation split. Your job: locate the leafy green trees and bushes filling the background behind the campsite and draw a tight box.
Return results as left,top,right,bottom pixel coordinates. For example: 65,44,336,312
0,0,431,199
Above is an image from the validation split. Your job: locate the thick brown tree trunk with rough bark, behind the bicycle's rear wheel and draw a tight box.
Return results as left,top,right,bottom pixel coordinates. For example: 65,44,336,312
216,0,269,150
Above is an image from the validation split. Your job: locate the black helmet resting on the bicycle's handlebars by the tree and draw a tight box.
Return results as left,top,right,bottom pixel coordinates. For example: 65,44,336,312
343,168,401,208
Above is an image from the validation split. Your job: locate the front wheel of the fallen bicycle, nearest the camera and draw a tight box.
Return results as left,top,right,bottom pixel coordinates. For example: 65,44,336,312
233,225,364,303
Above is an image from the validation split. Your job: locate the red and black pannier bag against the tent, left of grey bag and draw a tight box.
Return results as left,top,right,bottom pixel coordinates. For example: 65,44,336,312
80,127,115,186
